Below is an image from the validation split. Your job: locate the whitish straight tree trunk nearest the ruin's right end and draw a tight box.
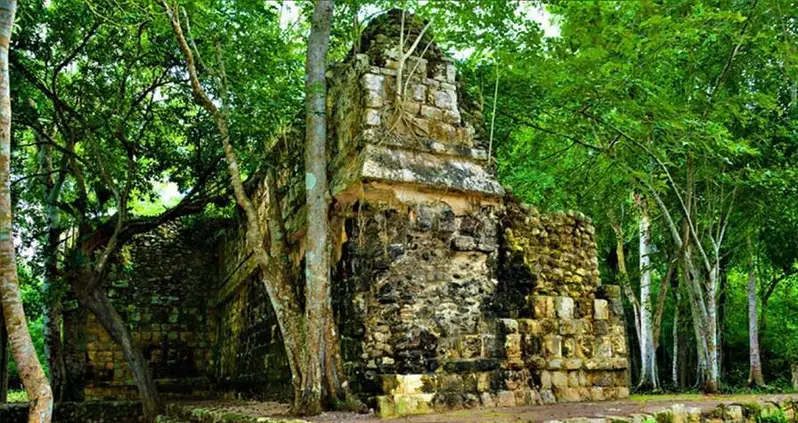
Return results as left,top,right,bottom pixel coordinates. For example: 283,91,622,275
638,200,659,390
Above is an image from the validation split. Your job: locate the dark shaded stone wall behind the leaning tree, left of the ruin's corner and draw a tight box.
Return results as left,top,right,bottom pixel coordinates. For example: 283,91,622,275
84,222,216,399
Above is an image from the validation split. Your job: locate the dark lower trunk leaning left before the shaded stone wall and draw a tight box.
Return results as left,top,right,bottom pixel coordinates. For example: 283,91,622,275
75,275,162,422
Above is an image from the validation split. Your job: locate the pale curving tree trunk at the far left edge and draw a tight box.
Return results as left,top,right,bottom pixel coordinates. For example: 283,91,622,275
0,0,53,422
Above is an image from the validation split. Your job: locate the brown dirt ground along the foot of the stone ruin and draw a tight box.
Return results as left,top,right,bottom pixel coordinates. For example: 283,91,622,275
173,394,798,423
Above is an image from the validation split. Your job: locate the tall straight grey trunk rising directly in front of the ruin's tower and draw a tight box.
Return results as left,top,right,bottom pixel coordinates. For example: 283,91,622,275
300,0,334,415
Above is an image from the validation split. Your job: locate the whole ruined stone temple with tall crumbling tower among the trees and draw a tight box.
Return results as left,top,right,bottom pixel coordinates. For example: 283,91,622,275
66,12,629,416
